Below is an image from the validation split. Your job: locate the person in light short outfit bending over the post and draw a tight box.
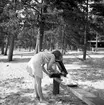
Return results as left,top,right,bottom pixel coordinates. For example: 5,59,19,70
27,50,62,102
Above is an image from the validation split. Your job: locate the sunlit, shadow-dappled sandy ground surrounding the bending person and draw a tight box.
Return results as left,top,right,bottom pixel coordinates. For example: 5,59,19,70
0,51,104,105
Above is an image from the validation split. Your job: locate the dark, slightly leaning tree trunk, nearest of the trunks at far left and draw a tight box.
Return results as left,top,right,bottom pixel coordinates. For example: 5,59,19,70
8,35,14,61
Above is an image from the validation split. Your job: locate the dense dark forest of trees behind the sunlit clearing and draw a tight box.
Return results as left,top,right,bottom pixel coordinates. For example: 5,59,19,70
0,0,104,61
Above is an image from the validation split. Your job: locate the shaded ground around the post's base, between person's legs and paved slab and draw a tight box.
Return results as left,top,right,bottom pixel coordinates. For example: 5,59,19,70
43,84,86,105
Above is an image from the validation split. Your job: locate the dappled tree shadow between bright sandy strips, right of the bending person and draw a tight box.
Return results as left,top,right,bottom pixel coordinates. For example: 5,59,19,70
68,68,104,82
